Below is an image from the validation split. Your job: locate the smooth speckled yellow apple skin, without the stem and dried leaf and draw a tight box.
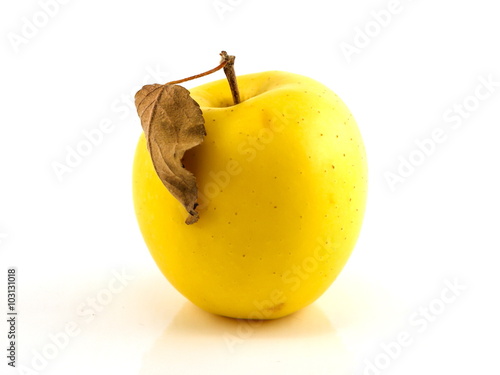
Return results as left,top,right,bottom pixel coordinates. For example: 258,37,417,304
133,71,367,319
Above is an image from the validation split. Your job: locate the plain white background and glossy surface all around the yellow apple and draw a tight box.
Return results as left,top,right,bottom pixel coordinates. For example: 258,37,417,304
0,0,500,375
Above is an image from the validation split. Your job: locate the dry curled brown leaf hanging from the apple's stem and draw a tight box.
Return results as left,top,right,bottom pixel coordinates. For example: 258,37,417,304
135,84,206,224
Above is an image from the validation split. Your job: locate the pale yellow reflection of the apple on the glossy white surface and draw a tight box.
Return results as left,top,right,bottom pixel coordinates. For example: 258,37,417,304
140,302,349,375
